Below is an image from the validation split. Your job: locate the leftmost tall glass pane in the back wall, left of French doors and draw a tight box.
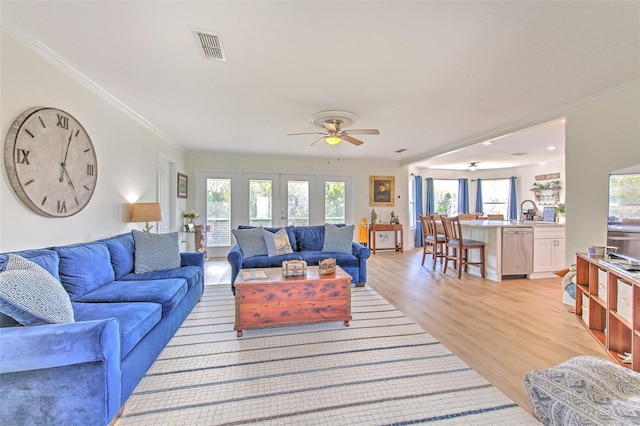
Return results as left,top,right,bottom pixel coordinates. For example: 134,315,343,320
206,179,231,247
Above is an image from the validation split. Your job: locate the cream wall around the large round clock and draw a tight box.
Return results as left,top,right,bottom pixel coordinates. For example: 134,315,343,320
0,32,186,251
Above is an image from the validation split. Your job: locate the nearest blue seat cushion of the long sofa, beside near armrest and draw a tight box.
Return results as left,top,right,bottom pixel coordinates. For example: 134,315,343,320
72,302,162,359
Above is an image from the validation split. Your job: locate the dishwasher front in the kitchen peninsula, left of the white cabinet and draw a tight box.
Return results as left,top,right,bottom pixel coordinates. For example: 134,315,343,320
502,227,533,276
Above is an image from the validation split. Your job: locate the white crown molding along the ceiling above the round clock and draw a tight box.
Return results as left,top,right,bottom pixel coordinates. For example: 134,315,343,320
2,16,180,148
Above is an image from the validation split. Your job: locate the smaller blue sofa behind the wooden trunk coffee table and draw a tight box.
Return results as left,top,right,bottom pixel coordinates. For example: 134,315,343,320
227,225,371,293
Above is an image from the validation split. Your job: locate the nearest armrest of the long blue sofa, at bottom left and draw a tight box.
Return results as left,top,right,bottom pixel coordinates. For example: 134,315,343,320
0,319,122,425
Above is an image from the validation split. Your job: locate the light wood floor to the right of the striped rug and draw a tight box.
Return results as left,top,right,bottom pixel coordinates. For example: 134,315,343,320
367,248,610,414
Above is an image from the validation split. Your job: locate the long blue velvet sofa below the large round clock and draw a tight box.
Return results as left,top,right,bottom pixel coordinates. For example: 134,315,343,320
0,233,204,426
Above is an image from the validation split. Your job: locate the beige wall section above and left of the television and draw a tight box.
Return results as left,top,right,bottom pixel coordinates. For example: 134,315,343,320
565,84,640,265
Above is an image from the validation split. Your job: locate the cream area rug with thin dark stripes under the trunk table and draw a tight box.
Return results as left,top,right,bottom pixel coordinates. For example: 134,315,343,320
117,285,539,426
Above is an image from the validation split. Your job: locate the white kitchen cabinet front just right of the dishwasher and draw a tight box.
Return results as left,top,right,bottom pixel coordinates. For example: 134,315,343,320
533,226,566,274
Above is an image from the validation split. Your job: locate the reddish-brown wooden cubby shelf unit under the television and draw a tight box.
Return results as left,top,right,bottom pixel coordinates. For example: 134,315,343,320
576,253,640,372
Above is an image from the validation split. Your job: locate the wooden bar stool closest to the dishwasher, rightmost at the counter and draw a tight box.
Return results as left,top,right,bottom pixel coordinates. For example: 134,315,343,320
442,217,485,278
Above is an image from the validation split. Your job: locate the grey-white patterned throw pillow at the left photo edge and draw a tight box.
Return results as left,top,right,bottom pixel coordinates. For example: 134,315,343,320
0,254,74,325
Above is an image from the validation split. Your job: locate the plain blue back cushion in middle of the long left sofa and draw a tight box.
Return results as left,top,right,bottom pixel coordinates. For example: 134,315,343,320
55,242,115,301
